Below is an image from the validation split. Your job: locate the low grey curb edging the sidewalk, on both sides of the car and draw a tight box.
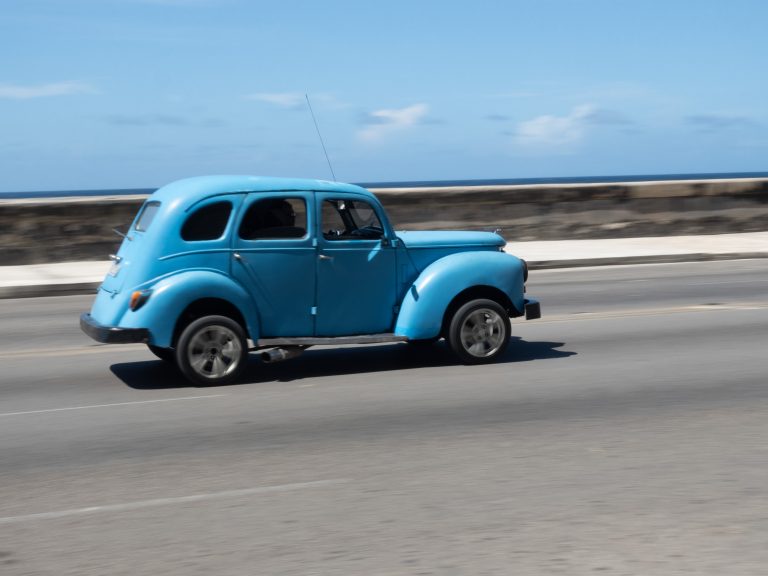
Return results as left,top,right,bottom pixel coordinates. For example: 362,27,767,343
0,252,768,300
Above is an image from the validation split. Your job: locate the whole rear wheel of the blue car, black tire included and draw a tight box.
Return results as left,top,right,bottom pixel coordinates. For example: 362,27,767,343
176,316,248,386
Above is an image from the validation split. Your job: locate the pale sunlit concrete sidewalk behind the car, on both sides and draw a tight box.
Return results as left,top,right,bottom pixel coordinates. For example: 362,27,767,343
0,232,768,298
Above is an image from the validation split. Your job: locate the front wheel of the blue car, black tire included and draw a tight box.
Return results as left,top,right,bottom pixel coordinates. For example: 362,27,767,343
448,298,511,364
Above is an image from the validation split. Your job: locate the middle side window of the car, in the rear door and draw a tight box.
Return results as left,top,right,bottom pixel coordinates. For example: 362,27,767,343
239,198,307,240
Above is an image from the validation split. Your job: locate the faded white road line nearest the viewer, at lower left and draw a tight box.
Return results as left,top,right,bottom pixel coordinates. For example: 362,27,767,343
0,478,349,524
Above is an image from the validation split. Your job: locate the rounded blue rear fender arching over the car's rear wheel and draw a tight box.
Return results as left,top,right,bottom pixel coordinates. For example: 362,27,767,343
114,270,259,347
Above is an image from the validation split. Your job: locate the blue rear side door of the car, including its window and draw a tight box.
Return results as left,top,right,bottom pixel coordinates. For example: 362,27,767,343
232,192,317,338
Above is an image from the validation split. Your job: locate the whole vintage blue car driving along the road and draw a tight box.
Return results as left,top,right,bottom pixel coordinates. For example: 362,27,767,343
80,176,541,385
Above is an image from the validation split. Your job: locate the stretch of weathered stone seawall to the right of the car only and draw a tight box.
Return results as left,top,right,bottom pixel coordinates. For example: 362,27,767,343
379,179,768,240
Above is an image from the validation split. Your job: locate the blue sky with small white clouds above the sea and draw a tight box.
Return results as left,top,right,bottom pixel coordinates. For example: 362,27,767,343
0,0,768,191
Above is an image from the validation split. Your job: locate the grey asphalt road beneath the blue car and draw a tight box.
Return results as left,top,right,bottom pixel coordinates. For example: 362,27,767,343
0,260,768,576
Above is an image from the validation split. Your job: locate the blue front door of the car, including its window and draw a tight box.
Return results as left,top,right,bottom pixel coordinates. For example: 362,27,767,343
315,193,397,336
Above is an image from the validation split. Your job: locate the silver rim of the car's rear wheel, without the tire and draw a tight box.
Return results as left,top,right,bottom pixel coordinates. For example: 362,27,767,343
187,325,243,380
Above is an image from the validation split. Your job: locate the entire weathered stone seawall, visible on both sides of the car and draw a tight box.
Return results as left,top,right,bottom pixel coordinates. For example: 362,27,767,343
0,179,768,266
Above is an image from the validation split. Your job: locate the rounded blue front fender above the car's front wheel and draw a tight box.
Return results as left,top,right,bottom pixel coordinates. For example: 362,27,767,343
395,252,525,340
